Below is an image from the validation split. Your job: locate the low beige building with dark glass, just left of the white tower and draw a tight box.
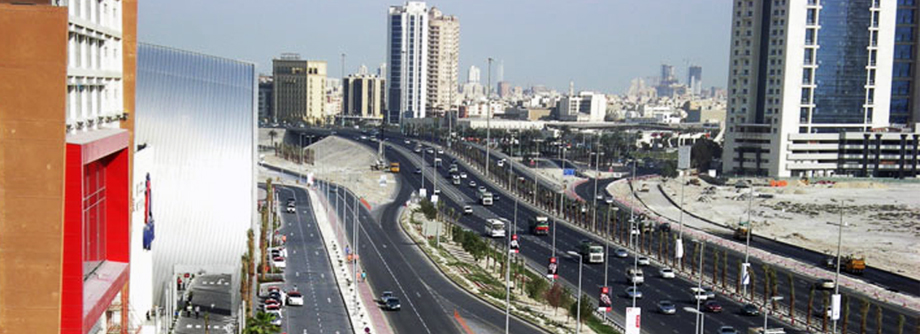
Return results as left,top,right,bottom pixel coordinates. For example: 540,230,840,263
342,73,386,119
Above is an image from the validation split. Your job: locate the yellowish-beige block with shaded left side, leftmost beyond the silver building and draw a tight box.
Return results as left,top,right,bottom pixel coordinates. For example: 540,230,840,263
272,54,326,124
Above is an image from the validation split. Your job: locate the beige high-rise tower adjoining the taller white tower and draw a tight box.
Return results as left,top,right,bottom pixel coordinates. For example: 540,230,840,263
428,8,460,113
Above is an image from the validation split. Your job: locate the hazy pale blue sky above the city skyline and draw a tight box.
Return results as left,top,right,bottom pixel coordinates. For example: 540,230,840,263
138,0,731,94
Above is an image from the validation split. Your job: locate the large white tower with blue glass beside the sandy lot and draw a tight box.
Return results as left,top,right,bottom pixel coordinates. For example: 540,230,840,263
722,0,920,177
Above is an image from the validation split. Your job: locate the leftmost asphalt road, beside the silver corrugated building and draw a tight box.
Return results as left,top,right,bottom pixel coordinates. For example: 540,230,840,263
276,186,351,333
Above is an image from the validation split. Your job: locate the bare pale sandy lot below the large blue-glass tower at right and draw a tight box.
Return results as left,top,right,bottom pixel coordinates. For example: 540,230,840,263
651,178,920,279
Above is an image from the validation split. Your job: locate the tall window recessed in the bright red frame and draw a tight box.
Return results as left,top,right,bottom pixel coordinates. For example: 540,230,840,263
83,161,106,276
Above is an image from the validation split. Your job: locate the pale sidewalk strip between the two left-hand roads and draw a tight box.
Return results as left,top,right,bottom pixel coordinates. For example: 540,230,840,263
308,184,393,334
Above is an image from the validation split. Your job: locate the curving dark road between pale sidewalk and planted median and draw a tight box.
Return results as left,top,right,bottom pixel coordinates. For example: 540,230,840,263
321,180,542,334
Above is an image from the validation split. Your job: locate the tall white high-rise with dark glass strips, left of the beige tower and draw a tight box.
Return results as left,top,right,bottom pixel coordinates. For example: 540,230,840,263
386,1,428,122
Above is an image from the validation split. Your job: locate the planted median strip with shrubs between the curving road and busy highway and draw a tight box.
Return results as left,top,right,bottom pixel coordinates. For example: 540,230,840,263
399,201,617,333
